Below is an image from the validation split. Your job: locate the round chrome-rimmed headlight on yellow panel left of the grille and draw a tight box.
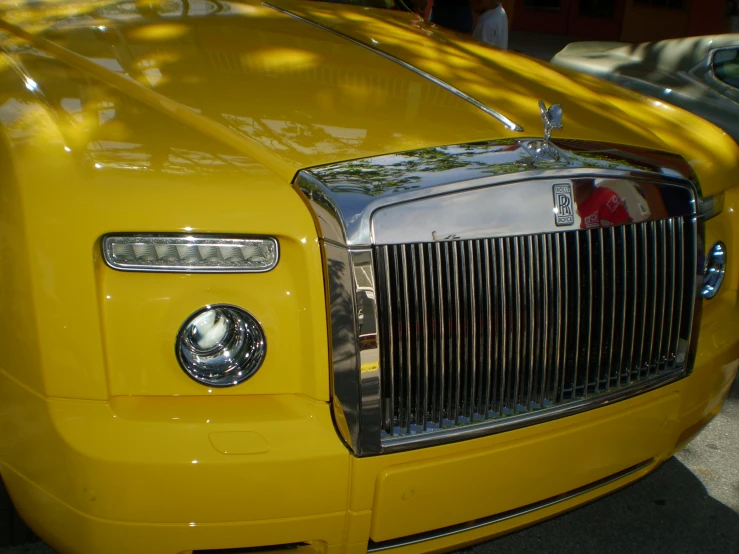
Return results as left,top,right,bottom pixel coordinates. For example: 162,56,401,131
176,305,267,387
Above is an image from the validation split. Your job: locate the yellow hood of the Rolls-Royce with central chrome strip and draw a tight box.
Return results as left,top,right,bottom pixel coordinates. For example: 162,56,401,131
2,0,737,187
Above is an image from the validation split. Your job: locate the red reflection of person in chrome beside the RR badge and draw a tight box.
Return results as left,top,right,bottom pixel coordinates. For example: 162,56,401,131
572,179,632,229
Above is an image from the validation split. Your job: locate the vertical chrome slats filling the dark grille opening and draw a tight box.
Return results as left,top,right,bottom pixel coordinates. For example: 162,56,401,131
374,217,697,438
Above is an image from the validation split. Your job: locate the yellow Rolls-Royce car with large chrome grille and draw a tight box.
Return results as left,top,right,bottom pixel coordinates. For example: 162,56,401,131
0,0,739,554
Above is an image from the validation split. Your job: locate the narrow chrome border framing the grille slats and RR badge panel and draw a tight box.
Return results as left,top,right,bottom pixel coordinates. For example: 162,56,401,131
295,140,704,456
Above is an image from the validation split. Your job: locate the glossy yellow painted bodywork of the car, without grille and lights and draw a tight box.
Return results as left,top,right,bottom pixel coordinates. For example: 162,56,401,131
0,0,739,554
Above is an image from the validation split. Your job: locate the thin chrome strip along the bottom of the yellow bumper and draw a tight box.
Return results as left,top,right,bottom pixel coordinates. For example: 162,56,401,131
367,459,655,552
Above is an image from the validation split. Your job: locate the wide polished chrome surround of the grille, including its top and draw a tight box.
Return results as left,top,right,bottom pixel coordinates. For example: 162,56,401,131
295,139,712,456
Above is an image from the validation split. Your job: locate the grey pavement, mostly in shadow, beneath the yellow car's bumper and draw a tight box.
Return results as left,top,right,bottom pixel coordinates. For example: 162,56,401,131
0,380,739,554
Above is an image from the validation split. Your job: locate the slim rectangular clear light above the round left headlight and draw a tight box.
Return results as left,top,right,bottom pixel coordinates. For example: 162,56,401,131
102,235,279,273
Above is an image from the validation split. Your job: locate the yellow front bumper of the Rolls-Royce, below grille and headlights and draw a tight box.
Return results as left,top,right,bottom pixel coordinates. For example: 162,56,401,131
0,294,739,554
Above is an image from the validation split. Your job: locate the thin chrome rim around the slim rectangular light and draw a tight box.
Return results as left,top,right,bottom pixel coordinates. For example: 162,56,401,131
100,233,280,273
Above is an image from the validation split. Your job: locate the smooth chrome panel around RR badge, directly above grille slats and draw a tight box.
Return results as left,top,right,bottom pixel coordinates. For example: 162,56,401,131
371,176,694,245
